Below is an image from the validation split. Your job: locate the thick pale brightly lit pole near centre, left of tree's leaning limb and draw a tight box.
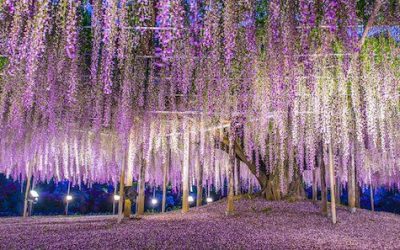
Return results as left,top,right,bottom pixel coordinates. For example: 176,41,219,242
182,118,190,213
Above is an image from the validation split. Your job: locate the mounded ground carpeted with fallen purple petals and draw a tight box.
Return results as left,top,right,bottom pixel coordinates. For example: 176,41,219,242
0,199,400,249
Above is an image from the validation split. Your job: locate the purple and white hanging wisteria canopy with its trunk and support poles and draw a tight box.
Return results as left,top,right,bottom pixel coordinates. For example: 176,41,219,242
0,0,400,223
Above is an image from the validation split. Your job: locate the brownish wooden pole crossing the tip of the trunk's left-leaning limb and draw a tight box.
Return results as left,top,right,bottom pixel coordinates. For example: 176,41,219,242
226,127,236,215
